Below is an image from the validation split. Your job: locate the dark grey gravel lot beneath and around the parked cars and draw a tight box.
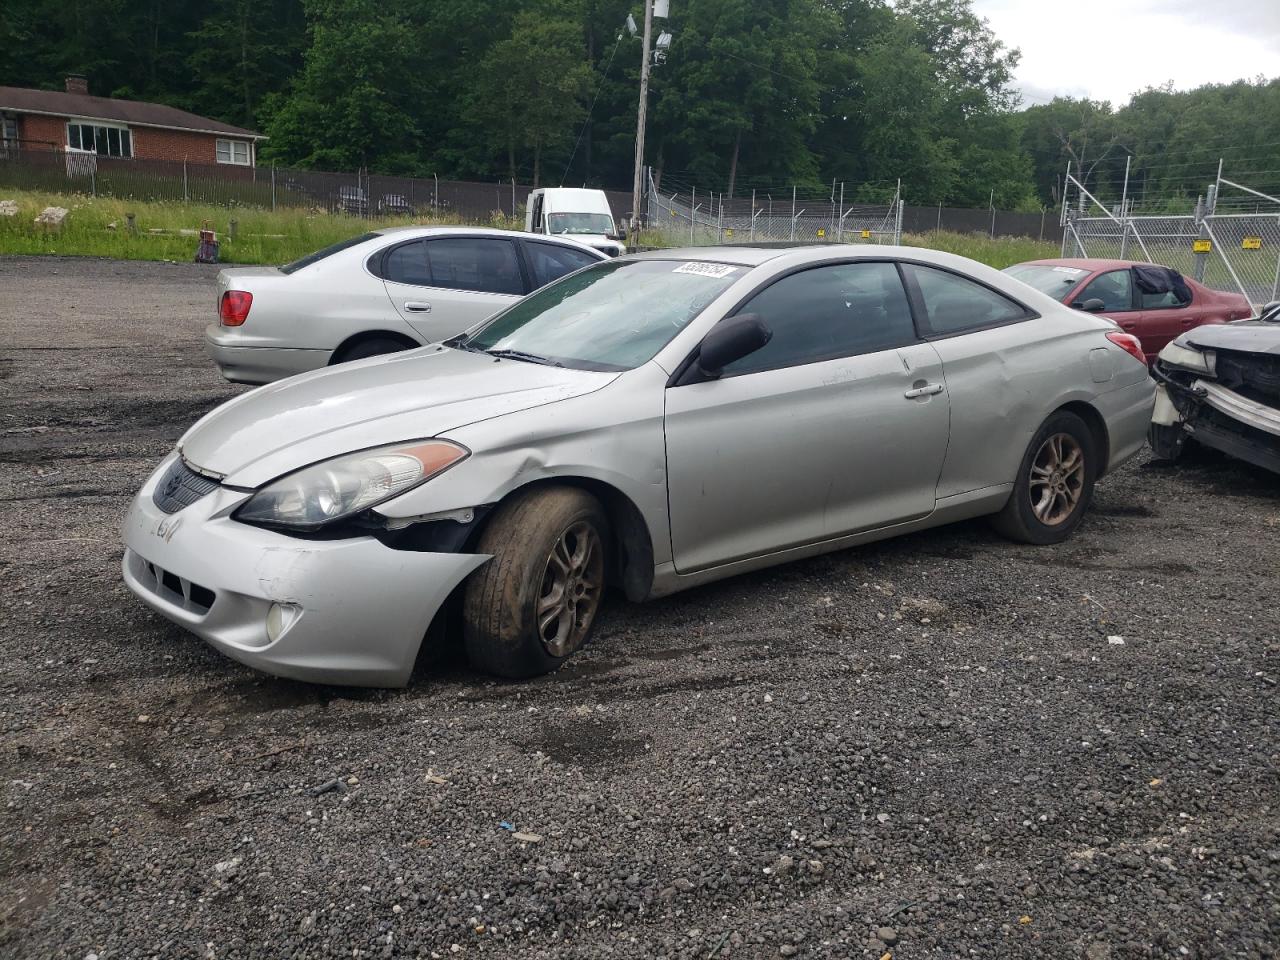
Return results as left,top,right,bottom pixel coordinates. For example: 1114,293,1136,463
0,259,1280,960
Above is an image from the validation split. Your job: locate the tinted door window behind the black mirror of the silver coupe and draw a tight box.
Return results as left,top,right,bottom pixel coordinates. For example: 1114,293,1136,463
724,262,916,376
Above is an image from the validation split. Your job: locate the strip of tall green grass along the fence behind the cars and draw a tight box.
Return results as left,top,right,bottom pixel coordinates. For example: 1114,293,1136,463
0,189,1057,269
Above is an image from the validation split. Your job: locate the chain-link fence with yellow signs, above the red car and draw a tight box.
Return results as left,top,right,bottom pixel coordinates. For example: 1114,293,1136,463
1061,168,1280,307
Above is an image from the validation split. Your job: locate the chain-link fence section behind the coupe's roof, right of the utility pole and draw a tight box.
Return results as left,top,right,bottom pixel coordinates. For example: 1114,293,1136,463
644,175,902,247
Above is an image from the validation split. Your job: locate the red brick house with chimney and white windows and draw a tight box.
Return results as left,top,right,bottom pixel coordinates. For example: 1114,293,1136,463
0,77,266,166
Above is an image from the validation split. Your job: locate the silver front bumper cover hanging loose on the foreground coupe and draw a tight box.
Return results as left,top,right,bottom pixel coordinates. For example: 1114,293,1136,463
122,460,488,686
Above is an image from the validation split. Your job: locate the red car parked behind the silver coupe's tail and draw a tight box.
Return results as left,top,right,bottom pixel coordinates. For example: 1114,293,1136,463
1005,257,1253,364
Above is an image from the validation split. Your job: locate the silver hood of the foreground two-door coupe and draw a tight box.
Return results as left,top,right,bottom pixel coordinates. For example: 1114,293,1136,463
178,347,617,488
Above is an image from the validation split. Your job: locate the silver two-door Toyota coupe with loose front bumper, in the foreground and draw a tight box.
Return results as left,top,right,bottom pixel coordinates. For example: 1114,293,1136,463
123,246,1155,686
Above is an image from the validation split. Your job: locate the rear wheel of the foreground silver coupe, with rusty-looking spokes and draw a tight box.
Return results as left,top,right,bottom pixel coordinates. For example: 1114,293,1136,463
992,411,1098,544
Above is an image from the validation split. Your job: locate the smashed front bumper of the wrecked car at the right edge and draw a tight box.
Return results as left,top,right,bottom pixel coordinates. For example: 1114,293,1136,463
1148,364,1280,474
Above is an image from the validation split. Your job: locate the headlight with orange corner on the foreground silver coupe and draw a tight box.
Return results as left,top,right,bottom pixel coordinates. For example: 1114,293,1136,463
234,440,470,530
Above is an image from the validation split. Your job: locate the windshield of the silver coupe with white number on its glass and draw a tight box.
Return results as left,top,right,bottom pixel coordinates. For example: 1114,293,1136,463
449,260,748,370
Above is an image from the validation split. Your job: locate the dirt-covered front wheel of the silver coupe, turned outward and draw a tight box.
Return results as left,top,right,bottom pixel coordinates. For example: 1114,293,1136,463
462,486,609,680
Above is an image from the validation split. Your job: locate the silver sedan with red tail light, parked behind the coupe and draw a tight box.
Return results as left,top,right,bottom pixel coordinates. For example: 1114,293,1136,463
205,227,607,384
